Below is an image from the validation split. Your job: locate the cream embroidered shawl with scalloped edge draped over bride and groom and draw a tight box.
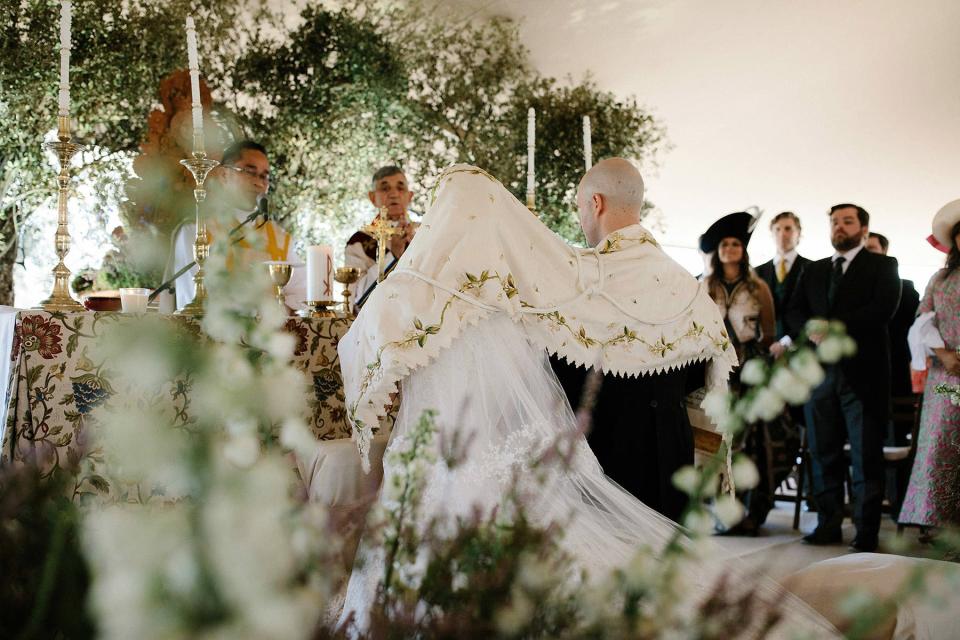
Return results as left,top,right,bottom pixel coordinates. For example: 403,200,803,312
338,165,737,469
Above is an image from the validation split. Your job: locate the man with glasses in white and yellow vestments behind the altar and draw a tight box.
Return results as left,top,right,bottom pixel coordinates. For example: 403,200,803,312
165,140,306,309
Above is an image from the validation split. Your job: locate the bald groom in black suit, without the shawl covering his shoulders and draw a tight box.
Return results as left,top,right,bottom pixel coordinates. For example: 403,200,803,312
551,158,704,521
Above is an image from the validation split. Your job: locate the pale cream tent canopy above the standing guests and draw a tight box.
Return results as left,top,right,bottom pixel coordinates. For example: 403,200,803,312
446,0,960,288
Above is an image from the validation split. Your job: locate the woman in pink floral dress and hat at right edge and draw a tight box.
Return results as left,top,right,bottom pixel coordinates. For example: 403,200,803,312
899,200,960,528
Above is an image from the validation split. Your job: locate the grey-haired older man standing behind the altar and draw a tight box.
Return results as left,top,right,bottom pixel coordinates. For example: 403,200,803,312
344,165,419,300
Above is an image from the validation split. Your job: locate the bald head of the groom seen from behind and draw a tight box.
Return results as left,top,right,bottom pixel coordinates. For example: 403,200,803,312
577,158,643,246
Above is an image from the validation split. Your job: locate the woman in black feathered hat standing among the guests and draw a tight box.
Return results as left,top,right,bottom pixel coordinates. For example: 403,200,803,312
700,211,784,535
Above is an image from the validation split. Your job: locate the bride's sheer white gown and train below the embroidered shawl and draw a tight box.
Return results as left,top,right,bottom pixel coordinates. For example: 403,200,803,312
344,313,836,637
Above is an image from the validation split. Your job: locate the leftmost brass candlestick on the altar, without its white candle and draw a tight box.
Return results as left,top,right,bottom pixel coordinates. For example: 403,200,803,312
37,116,86,312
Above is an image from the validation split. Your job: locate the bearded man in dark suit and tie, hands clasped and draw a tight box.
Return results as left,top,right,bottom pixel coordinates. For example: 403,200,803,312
787,204,900,551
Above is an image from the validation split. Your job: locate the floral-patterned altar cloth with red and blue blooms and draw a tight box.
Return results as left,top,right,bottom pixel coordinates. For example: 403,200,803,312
0,311,362,502
